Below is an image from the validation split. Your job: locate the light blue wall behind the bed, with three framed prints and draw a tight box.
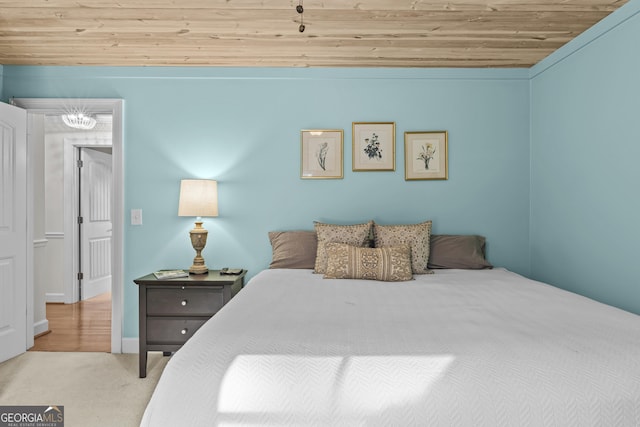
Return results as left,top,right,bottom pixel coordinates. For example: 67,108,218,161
3,66,529,337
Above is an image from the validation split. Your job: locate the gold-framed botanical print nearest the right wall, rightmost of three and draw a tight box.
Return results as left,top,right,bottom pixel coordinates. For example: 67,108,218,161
404,131,449,181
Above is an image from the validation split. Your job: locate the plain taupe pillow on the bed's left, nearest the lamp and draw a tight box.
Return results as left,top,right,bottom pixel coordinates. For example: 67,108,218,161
269,230,318,269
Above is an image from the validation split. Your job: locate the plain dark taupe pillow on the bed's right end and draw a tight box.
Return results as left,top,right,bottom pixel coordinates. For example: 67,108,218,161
428,234,493,270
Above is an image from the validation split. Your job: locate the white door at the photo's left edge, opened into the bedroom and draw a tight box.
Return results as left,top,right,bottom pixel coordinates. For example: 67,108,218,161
0,103,27,362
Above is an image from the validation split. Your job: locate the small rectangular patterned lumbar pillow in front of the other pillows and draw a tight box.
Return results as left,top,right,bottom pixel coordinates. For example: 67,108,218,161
323,243,413,282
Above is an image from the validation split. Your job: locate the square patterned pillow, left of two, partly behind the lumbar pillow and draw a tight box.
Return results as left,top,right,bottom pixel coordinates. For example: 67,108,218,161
313,221,373,274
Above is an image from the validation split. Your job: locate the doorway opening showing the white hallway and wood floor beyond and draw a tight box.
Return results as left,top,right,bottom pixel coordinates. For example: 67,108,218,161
31,114,112,352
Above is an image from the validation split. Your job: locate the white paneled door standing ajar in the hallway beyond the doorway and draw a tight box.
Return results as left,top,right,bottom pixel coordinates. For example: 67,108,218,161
80,148,112,300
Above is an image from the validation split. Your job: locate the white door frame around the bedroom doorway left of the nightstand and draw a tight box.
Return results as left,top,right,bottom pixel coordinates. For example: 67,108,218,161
12,98,124,353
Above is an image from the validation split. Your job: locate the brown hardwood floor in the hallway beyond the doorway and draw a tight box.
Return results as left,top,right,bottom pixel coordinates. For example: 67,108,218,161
29,293,111,352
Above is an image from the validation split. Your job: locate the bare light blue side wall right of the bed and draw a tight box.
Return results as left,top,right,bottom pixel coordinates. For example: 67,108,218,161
530,1,640,314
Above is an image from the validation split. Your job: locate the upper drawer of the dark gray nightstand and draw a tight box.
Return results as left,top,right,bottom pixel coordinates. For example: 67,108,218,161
147,286,224,316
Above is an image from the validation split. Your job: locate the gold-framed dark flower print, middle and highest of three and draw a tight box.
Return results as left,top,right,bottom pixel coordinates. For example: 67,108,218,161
352,122,396,172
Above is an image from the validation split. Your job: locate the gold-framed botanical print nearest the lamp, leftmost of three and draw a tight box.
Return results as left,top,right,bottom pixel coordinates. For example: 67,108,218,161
300,129,344,179
